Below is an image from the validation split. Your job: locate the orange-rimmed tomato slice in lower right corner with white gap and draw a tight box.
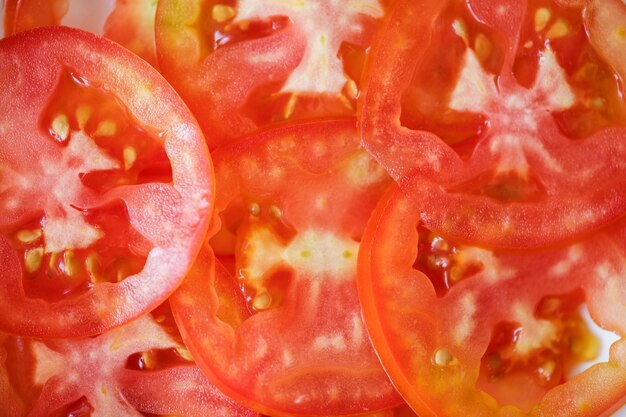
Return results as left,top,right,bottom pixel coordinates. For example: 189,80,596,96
358,187,626,417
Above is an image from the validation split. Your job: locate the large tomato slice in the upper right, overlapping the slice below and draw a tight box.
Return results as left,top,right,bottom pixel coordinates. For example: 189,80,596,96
360,0,626,248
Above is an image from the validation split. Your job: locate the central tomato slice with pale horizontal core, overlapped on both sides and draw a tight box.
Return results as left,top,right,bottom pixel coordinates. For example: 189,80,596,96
172,120,401,416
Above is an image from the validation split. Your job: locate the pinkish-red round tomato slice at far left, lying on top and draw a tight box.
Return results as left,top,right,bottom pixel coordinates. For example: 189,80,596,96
0,27,213,337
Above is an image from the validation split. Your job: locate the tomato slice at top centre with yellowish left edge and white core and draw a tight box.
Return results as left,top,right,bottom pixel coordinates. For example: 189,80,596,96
156,0,383,148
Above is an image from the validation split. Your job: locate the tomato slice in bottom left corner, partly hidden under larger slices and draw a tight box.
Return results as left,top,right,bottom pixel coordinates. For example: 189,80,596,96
5,316,258,417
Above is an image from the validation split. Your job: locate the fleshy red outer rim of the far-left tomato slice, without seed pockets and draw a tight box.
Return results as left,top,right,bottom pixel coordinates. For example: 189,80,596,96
0,27,214,337
